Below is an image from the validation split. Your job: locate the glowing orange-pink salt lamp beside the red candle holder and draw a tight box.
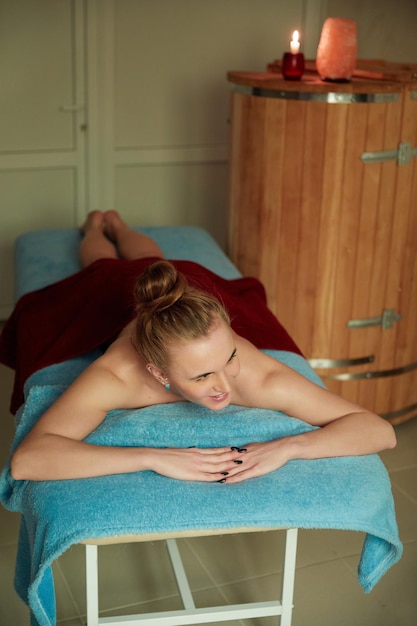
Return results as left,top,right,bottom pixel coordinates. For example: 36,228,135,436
316,17,357,82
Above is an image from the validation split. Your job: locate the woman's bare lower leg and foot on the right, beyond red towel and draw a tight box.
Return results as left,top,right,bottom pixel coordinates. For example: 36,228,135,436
104,211,164,260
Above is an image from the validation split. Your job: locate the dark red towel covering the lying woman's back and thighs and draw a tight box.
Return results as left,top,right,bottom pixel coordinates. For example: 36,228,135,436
0,258,301,413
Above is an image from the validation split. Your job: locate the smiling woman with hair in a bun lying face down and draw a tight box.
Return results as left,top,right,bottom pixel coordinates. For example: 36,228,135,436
11,211,395,483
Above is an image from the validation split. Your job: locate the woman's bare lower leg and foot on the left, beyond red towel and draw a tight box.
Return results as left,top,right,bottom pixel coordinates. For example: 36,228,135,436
79,211,117,267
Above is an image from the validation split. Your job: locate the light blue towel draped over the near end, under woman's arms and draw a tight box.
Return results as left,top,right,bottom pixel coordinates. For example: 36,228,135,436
0,351,402,626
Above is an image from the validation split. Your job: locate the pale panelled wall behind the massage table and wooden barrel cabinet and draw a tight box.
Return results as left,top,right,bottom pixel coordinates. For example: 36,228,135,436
0,0,417,318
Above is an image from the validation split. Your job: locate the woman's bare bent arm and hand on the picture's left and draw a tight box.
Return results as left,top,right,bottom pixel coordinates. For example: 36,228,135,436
11,364,238,481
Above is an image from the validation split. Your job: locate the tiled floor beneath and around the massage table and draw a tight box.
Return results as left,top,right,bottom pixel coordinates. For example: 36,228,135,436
0,366,417,626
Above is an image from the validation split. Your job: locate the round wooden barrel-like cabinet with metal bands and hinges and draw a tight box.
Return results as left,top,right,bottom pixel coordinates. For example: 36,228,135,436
228,65,417,423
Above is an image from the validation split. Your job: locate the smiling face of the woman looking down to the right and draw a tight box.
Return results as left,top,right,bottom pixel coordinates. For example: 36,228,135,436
167,320,240,411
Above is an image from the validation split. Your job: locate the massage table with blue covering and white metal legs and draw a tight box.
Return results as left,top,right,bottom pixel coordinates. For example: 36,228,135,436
0,227,402,626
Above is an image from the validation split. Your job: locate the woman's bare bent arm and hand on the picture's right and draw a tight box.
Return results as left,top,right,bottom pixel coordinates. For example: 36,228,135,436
227,352,396,483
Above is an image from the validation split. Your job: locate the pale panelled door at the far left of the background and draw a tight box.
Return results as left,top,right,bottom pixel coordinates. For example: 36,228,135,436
0,0,85,318
